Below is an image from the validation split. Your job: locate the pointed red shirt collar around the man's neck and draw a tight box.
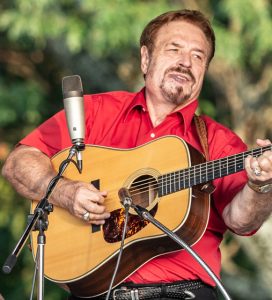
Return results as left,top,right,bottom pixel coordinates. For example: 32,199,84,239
124,88,198,133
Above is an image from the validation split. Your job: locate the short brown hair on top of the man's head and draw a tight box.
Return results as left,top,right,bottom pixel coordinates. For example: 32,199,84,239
140,9,215,63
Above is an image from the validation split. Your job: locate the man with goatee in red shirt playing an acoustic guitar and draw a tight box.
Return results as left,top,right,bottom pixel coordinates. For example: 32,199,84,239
3,10,272,300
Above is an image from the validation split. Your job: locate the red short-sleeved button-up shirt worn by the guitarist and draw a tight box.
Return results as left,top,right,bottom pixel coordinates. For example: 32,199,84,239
20,89,247,285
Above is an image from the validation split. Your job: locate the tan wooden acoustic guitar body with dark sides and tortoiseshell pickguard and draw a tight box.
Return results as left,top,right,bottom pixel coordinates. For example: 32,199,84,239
32,136,210,297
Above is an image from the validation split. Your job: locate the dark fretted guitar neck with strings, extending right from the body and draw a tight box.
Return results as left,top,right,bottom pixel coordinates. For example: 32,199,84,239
158,145,272,197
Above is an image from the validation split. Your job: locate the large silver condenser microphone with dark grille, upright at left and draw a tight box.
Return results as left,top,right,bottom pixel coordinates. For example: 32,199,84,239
62,75,85,173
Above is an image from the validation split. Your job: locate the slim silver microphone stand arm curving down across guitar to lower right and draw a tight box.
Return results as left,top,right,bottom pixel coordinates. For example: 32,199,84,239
131,202,231,300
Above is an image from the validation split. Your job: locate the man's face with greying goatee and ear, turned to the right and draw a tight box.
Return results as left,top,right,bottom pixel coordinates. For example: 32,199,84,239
141,21,210,106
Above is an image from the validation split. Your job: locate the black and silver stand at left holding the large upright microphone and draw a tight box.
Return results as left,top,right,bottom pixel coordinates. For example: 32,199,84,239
2,143,85,300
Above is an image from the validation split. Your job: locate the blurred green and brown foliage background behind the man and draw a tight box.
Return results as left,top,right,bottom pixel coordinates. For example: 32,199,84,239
0,0,272,300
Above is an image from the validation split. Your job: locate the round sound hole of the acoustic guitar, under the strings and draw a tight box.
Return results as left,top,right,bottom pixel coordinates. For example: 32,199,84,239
129,175,158,208
